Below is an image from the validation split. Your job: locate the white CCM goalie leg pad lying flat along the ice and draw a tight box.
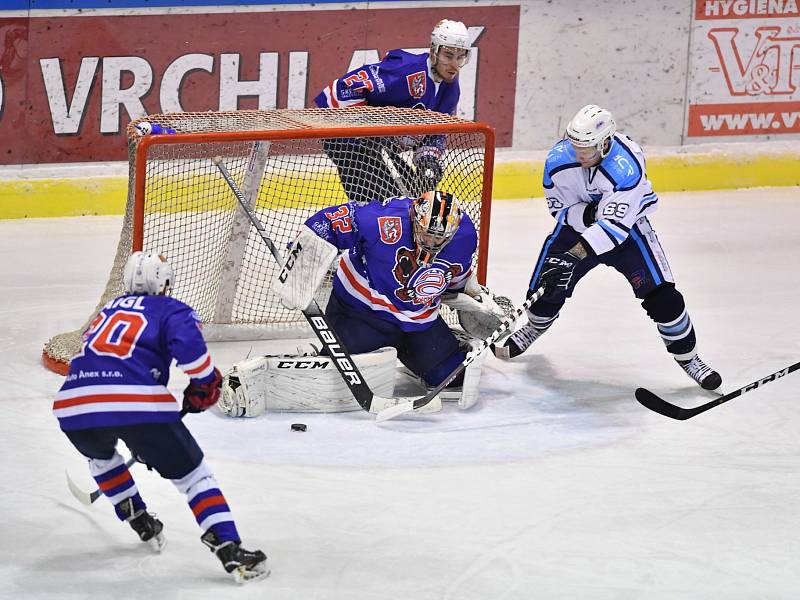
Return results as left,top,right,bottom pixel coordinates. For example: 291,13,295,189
217,348,397,417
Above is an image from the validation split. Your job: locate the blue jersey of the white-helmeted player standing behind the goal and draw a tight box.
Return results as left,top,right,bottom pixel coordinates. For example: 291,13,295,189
314,50,460,115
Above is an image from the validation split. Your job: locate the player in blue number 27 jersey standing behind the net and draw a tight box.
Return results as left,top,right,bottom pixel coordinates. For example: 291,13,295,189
314,20,470,203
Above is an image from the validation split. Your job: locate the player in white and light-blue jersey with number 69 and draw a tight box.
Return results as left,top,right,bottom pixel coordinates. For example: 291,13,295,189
493,105,722,390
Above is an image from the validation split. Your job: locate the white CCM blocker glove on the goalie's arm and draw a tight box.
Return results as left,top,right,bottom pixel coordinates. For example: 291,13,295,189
272,225,339,310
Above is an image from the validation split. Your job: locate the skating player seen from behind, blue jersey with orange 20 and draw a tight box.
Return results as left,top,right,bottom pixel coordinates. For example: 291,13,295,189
53,252,269,583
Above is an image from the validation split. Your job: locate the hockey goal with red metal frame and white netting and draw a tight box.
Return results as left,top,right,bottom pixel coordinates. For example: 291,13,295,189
42,107,494,374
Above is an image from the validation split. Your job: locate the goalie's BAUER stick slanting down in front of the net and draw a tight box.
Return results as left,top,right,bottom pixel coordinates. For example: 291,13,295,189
211,156,406,418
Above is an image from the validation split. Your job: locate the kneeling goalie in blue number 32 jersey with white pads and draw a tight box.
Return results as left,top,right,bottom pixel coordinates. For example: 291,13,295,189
219,191,513,417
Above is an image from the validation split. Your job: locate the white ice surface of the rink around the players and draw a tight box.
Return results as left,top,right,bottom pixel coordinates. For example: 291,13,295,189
0,188,800,600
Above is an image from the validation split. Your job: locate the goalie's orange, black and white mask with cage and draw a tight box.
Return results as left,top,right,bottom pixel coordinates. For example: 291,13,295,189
411,191,463,265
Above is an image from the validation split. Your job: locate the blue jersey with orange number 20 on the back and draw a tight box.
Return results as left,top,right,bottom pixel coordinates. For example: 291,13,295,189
53,295,214,431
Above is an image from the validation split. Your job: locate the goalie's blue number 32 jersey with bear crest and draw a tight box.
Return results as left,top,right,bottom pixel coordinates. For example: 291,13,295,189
306,197,478,331
